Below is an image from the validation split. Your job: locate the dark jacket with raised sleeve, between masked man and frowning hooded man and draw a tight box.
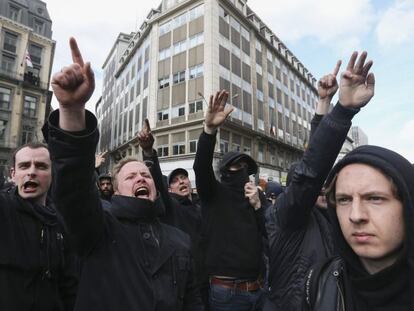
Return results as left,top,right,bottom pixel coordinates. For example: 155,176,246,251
265,104,357,311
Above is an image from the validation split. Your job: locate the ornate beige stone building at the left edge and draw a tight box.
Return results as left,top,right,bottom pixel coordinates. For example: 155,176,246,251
0,0,55,174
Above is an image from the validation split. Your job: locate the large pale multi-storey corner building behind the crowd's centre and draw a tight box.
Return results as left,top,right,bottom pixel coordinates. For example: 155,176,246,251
97,0,317,181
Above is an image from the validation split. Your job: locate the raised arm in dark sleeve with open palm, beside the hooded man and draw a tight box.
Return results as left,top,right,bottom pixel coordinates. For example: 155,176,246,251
268,52,375,234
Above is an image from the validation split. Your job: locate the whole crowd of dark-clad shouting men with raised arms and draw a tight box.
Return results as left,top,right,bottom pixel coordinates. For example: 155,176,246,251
0,38,414,311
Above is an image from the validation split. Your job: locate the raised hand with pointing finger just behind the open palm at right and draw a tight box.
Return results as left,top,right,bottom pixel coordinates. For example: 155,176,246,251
309,60,342,140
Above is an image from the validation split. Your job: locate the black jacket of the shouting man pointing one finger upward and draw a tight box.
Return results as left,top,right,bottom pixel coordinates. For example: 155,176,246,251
43,111,202,311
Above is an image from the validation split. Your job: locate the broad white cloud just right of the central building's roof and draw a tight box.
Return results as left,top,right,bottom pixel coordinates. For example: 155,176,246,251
248,0,375,51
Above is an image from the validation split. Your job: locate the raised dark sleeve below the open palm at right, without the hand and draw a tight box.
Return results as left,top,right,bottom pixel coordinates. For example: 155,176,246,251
268,104,359,232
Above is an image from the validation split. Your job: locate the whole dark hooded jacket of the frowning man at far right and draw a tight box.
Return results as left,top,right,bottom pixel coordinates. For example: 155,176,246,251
306,146,414,311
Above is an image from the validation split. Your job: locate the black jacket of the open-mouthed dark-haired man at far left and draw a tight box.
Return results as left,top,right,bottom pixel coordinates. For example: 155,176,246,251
0,191,78,311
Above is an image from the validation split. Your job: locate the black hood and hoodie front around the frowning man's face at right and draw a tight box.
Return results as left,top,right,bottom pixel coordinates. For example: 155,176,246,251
326,146,414,311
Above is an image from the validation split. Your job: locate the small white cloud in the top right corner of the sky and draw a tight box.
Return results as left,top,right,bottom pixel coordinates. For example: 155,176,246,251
376,0,414,50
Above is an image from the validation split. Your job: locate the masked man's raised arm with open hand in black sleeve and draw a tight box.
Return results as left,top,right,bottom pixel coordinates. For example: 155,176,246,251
193,90,234,202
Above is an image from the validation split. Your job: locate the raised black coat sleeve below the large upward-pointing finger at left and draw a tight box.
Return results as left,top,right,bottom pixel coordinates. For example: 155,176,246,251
43,110,104,256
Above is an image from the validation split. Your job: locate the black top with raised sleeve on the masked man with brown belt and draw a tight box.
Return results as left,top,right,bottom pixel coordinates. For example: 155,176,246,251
194,132,265,278
